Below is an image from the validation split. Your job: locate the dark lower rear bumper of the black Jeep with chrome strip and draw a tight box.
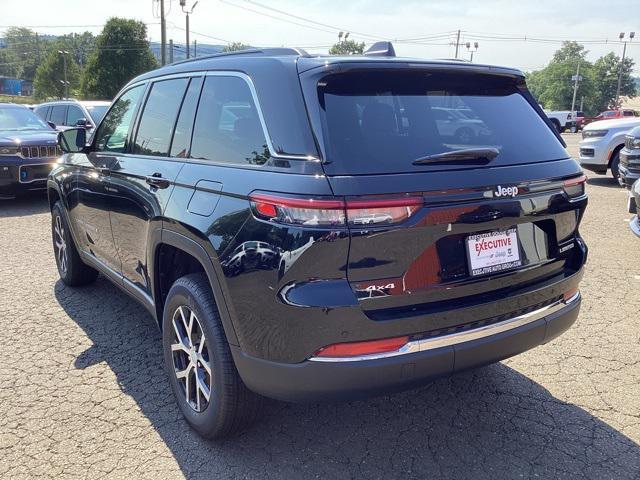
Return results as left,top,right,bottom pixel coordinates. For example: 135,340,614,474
231,294,581,402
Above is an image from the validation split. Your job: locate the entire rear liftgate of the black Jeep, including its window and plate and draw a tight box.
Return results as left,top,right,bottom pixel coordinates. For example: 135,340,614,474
301,63,586,325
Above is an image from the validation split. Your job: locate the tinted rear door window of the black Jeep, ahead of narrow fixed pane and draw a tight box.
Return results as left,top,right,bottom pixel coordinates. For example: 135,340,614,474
133,78,189,157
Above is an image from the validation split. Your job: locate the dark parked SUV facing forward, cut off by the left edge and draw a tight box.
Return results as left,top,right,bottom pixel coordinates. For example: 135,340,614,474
0,103,62,199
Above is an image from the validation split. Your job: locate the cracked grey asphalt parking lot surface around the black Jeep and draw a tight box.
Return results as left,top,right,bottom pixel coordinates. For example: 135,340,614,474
0,135,640,480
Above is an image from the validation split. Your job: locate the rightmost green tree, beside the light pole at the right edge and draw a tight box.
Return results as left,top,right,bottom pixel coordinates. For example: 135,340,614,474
593,52,636,111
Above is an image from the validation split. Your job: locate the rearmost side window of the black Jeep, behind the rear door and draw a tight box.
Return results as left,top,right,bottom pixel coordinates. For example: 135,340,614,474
191,76,270,165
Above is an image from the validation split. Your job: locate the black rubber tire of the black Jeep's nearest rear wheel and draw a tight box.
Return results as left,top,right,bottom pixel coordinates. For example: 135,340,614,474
162,273,262,438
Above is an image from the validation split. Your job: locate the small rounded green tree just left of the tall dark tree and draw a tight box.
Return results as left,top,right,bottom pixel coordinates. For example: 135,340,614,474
33,42,80,100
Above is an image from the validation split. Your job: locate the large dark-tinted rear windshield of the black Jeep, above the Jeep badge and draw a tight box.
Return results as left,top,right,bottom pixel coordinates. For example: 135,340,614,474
318,71,567,175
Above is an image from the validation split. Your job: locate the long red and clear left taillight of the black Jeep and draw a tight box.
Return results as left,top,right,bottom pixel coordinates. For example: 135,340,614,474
249,193,423,227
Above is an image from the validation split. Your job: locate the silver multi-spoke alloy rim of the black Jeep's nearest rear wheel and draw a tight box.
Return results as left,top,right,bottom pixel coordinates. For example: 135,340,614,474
171,306,213,412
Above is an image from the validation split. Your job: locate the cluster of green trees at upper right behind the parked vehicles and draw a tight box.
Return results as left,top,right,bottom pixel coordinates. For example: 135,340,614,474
527,42,635,115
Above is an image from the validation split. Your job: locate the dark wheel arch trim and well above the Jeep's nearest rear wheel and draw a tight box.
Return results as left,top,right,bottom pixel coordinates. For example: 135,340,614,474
149,229,238,346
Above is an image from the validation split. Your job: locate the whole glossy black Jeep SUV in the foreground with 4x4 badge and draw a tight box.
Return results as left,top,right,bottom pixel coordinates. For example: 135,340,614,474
48,48,587,437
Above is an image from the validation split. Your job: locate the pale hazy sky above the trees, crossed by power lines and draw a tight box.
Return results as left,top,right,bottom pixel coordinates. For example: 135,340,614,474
0,0,640,75
